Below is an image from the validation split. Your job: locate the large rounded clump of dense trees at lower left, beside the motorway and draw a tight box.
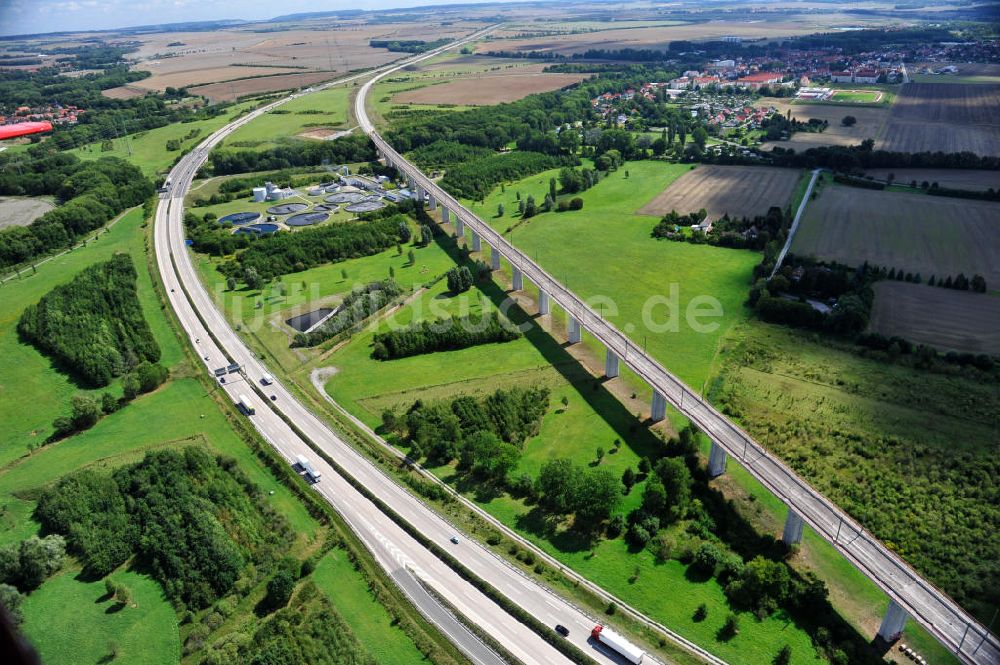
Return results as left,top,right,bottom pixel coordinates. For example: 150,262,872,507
34,447,292,609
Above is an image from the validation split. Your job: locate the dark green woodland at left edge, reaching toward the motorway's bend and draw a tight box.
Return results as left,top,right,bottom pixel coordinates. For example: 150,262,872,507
0,150,153,267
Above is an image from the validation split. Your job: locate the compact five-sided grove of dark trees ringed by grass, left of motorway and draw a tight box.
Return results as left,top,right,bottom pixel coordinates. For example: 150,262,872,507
17,254,160,386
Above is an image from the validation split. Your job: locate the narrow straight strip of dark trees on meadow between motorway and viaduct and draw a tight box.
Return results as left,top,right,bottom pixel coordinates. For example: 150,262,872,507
372,310,521,360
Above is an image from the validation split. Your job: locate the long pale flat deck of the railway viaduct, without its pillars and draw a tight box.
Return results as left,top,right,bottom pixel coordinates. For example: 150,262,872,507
355,48,1000,665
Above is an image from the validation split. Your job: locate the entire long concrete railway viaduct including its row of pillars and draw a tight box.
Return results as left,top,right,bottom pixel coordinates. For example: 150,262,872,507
364,76,1000,665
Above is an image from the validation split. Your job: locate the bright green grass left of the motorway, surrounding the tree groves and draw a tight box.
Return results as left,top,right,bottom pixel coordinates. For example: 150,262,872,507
0,210,430,663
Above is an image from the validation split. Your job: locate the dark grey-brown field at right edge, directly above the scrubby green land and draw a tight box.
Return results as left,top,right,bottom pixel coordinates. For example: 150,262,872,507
870,281,1000,355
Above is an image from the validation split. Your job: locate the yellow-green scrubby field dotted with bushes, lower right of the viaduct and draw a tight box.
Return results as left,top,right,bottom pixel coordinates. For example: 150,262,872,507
714,323,1000,640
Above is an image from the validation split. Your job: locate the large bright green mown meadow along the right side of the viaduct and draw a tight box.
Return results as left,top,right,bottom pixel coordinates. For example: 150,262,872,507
467,162,760,389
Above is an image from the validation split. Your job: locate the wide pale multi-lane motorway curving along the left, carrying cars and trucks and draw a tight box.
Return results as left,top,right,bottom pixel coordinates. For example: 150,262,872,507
154,32,688,665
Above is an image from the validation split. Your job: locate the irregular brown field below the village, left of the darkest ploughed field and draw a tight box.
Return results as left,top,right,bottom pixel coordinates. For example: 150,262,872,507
764,99,890,152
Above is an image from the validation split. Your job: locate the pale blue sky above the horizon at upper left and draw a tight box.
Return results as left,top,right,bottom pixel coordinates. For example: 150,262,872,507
0,0,516,35
